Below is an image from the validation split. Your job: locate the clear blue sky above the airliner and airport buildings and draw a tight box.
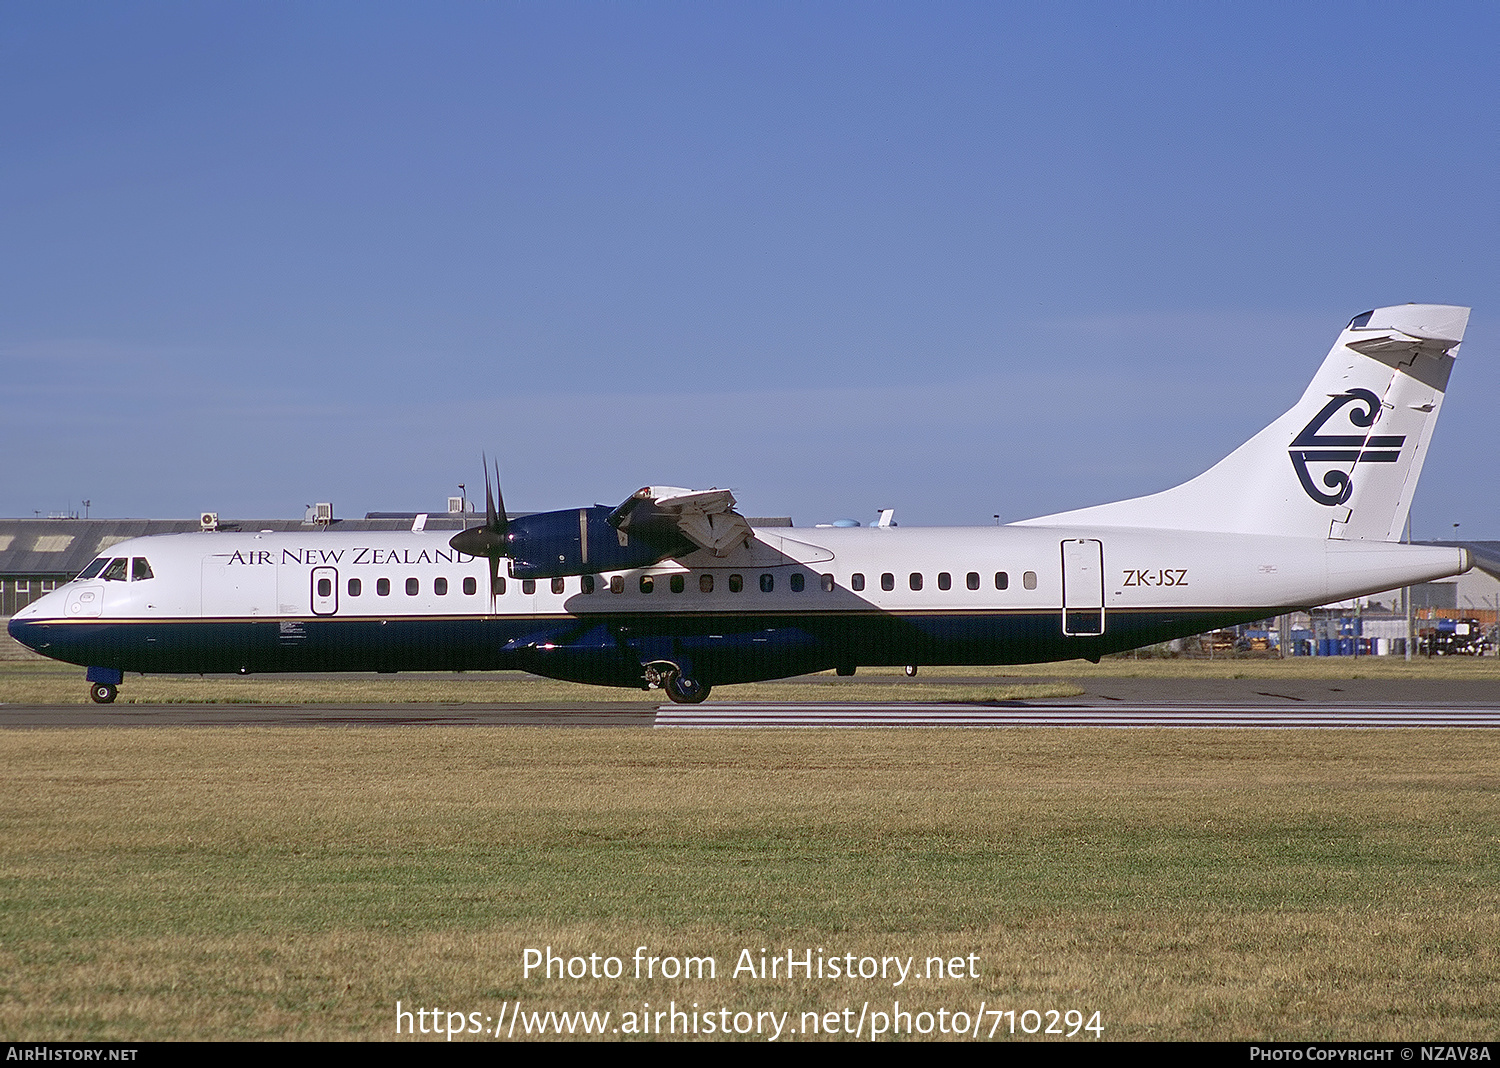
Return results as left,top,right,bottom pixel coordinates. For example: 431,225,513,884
0,0,1500,537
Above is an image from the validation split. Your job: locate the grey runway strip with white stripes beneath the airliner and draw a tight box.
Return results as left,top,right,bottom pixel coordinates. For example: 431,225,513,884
0,675,1500,729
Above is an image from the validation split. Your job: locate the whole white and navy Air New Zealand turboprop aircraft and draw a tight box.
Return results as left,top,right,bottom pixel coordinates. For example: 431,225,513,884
11,305,1470,702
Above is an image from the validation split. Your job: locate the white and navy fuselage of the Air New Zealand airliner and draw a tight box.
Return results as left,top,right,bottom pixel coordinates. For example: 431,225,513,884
12,527,1469,684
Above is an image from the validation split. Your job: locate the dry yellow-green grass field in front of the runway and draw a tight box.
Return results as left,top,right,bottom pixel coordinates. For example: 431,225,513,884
0,728,1500,1040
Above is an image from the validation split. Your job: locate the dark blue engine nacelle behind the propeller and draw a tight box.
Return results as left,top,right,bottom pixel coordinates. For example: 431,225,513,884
506,504,698,579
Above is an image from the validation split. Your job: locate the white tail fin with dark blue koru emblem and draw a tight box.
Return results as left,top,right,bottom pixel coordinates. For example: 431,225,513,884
1019,305,1469,542
